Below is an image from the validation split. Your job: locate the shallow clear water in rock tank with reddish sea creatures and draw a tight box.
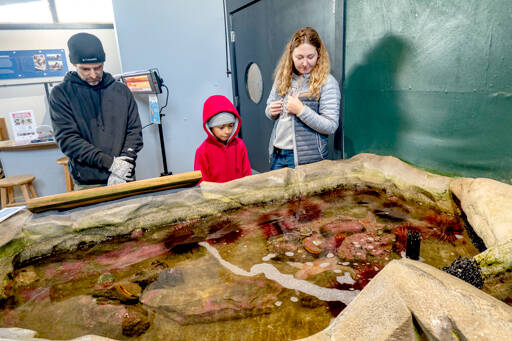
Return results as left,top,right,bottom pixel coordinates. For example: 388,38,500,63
0,187,478,340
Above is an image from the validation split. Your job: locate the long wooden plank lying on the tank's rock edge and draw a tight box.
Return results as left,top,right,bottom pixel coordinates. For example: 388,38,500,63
27,171,201,212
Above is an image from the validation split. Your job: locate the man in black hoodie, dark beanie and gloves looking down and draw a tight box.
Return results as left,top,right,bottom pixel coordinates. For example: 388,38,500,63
50,33,142,189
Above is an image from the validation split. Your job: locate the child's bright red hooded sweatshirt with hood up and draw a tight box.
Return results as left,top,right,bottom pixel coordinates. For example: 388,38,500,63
194,95,251,182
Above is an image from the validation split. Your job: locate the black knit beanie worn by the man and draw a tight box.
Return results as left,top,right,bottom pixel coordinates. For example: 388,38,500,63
68,33,105,64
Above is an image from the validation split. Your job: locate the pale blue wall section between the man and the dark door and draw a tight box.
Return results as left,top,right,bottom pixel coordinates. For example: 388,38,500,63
113,0,233,179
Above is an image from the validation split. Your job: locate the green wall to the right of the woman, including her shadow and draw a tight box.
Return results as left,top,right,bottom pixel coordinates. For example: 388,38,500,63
344,0,512,183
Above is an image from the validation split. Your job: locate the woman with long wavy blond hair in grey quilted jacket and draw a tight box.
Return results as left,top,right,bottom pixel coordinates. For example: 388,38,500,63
265,27,341,170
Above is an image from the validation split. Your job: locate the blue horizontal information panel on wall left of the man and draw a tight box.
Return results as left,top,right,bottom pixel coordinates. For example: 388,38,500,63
0,49,68,79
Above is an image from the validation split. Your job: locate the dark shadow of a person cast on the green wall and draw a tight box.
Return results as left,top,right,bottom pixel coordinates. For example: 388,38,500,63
344,35,412,157
